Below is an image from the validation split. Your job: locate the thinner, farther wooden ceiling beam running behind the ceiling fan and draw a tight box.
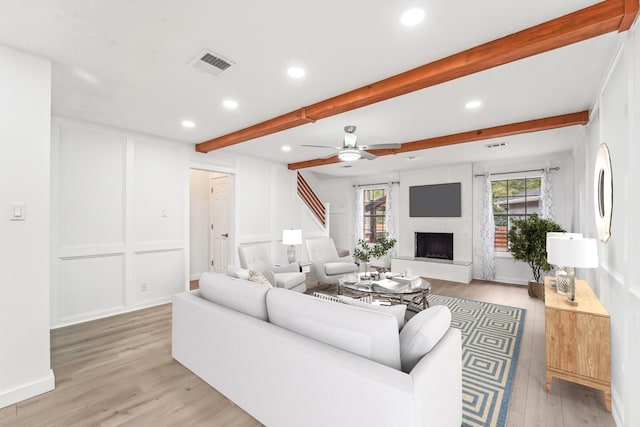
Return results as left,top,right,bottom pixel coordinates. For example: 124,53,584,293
288,111,589,170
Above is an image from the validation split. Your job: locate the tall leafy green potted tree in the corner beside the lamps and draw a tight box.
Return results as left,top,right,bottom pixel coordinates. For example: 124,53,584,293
507,214,565,299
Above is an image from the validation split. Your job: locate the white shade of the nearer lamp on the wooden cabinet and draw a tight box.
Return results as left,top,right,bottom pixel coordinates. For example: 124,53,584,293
547,237,598,268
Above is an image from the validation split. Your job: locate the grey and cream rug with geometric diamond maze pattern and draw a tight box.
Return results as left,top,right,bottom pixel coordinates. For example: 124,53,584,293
428,295,526,427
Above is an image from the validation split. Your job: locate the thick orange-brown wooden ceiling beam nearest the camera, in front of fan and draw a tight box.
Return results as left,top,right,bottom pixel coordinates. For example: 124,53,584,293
196,0,638,153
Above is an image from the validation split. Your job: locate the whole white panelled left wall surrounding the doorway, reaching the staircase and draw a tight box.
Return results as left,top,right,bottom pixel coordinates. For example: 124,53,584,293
51,117,322,327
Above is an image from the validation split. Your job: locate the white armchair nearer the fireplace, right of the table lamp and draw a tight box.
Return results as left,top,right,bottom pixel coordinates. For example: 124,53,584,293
306,238,358,285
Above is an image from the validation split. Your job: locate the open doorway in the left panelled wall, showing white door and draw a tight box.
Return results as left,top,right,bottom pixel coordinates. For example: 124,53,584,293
189,169,235,281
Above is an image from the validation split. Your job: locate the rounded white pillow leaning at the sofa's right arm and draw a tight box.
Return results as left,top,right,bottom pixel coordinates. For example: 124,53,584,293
400,305,451,373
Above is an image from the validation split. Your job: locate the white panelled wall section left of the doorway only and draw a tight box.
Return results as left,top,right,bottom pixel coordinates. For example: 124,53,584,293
51,118,190,327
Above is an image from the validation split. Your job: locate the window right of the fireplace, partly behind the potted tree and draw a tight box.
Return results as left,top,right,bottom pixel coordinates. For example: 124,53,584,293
491,177,541,252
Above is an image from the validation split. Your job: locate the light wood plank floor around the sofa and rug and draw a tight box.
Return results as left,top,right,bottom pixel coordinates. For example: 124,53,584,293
0,280,615,427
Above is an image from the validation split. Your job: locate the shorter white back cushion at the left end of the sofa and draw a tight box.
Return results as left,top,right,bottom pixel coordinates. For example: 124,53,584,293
200,273,271,320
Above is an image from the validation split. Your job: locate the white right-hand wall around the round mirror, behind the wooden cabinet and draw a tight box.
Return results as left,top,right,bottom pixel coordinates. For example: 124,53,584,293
574,23,640,427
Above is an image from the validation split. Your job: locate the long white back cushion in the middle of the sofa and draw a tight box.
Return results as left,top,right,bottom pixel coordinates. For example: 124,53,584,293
267,288,400,369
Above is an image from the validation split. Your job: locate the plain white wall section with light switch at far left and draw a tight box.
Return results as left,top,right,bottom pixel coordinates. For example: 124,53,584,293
0,46,55,408
